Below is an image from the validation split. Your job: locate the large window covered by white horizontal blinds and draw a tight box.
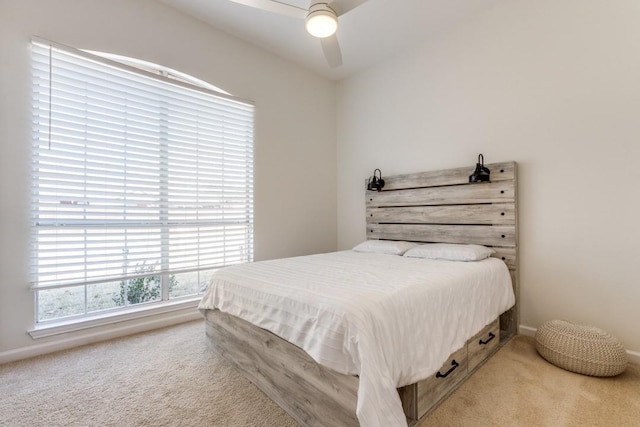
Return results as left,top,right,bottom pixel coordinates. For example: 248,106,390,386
31,40,254,322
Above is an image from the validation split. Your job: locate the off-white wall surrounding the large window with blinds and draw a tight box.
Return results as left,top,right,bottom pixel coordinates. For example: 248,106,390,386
0,0,337,361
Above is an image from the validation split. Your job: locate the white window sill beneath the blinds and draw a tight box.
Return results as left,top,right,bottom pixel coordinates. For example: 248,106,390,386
27,297,201,340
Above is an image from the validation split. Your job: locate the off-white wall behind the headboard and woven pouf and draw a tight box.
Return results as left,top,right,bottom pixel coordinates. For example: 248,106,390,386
337,0,640,352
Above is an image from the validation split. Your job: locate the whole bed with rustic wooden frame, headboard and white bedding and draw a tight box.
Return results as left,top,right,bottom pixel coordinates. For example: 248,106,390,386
200,162,518,426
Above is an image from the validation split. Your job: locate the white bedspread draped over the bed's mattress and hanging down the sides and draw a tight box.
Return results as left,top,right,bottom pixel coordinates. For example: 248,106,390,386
199,251,515,427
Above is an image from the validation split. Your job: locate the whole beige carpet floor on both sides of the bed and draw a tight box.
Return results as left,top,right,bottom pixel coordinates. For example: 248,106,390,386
0,321,640,427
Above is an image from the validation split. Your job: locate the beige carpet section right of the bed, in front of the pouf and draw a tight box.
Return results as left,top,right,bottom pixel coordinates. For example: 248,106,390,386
421,335,640,427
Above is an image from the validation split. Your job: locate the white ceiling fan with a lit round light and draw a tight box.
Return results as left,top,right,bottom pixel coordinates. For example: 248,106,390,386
231,0,367,68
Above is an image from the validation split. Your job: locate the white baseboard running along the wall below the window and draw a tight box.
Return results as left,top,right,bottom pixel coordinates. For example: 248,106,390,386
0,309,204,365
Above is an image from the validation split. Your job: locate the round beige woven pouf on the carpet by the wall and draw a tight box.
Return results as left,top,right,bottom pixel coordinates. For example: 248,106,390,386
535,320,628,377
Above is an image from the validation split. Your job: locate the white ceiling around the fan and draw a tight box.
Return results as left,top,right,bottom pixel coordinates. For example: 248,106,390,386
160,0,503,80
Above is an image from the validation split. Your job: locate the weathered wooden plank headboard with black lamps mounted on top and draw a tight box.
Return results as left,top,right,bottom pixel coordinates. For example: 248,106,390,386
366,162,519,339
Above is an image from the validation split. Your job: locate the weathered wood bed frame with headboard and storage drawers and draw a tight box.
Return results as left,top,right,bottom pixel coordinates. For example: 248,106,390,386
205,162,519,426
